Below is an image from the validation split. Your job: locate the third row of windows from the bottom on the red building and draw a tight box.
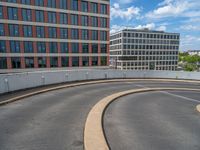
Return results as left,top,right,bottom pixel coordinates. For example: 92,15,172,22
0,24,108,41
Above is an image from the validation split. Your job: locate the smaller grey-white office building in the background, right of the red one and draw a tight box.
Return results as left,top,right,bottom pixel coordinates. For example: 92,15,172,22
110,29,180,70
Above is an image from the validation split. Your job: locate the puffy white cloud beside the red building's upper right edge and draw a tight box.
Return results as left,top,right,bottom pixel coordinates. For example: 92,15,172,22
111,3,141,20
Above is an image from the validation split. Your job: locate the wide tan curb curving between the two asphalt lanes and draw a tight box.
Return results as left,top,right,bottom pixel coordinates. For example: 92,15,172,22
84,88,200,150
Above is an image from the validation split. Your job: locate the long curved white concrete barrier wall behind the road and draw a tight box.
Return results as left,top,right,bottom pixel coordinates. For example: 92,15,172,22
0,69,200,94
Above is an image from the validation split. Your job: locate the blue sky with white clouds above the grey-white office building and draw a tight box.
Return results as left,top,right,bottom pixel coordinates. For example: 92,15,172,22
110,0,200,51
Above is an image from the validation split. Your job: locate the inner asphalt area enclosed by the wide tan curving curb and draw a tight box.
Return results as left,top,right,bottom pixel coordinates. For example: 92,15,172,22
104,91,200,150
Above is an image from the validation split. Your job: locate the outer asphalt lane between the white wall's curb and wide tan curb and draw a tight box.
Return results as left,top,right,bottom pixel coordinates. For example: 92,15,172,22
0,81,200,150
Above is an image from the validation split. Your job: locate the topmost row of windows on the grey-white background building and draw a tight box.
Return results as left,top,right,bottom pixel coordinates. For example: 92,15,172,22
110,32,179,40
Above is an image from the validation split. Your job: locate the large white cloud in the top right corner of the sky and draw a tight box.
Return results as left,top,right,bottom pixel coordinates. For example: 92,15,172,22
146,0,200,19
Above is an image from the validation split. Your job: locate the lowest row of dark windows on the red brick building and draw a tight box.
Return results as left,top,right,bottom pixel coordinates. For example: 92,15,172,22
0,56,107,69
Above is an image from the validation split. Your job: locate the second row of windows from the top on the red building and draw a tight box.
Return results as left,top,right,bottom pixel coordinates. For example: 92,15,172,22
0,6,107,28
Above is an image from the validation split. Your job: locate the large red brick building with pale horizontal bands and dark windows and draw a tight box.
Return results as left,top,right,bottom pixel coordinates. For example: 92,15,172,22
0,0,110,69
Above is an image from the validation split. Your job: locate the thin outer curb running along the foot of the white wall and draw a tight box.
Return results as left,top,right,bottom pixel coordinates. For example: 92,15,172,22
0,79,200,106
